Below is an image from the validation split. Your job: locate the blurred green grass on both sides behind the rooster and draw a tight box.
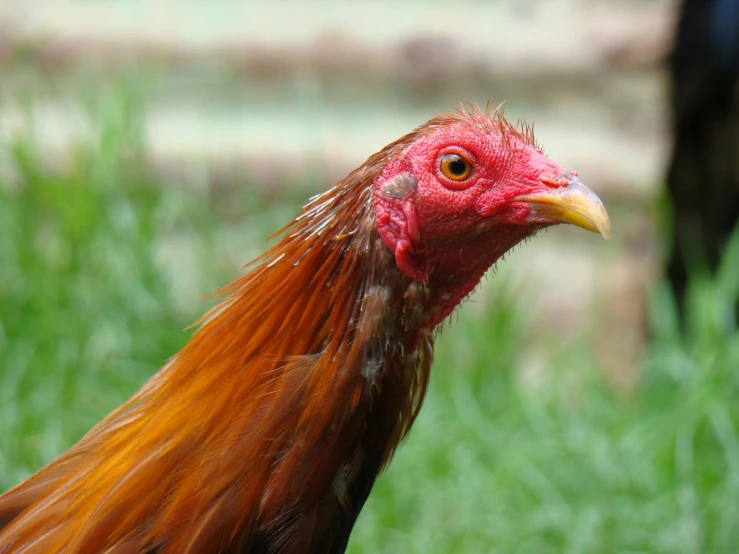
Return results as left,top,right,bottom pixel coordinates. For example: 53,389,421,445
0,88,739,554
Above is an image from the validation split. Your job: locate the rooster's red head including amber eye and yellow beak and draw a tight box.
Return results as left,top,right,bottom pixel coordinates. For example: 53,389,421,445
374,106,610,326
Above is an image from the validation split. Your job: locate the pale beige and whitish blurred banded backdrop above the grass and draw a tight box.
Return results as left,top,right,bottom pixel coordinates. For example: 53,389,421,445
0,0,675,386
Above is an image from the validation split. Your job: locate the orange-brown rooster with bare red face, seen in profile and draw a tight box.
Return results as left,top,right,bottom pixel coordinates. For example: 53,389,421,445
0,108,610,554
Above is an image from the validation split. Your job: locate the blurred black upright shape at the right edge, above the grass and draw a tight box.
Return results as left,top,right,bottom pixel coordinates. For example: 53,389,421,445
667,0,739,310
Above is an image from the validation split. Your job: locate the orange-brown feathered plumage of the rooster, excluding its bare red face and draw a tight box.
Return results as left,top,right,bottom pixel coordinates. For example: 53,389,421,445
0,113,492,554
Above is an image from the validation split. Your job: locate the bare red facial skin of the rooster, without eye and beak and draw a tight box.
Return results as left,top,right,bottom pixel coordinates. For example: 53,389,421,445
375,122,575,330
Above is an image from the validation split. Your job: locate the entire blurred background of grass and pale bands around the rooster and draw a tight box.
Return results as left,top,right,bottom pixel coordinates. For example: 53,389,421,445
0,0,739,554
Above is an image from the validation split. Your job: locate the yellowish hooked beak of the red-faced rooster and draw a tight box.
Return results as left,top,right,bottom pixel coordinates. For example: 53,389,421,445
513,175,611,240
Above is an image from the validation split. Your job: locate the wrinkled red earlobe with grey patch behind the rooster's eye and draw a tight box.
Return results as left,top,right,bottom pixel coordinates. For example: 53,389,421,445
375,173,429,281
